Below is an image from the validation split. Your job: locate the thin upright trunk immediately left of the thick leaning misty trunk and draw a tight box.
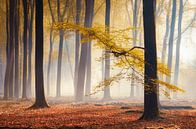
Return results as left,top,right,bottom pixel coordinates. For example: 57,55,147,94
74,0,81,95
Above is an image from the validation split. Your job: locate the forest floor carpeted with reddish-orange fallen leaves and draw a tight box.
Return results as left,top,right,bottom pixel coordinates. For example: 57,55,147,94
0,98,196,129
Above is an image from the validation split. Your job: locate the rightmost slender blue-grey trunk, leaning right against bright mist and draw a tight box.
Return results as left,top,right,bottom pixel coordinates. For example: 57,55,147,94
174,0,183,97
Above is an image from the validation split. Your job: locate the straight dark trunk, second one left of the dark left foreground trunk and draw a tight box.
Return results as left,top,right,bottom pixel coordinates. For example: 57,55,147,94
22,0,28,99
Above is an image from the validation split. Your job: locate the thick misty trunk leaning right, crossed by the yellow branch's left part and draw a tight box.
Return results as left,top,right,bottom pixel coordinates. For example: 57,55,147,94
76,0,94,101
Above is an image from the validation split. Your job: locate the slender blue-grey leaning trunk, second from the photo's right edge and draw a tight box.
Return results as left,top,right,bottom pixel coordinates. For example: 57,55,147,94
166,0,176,83
